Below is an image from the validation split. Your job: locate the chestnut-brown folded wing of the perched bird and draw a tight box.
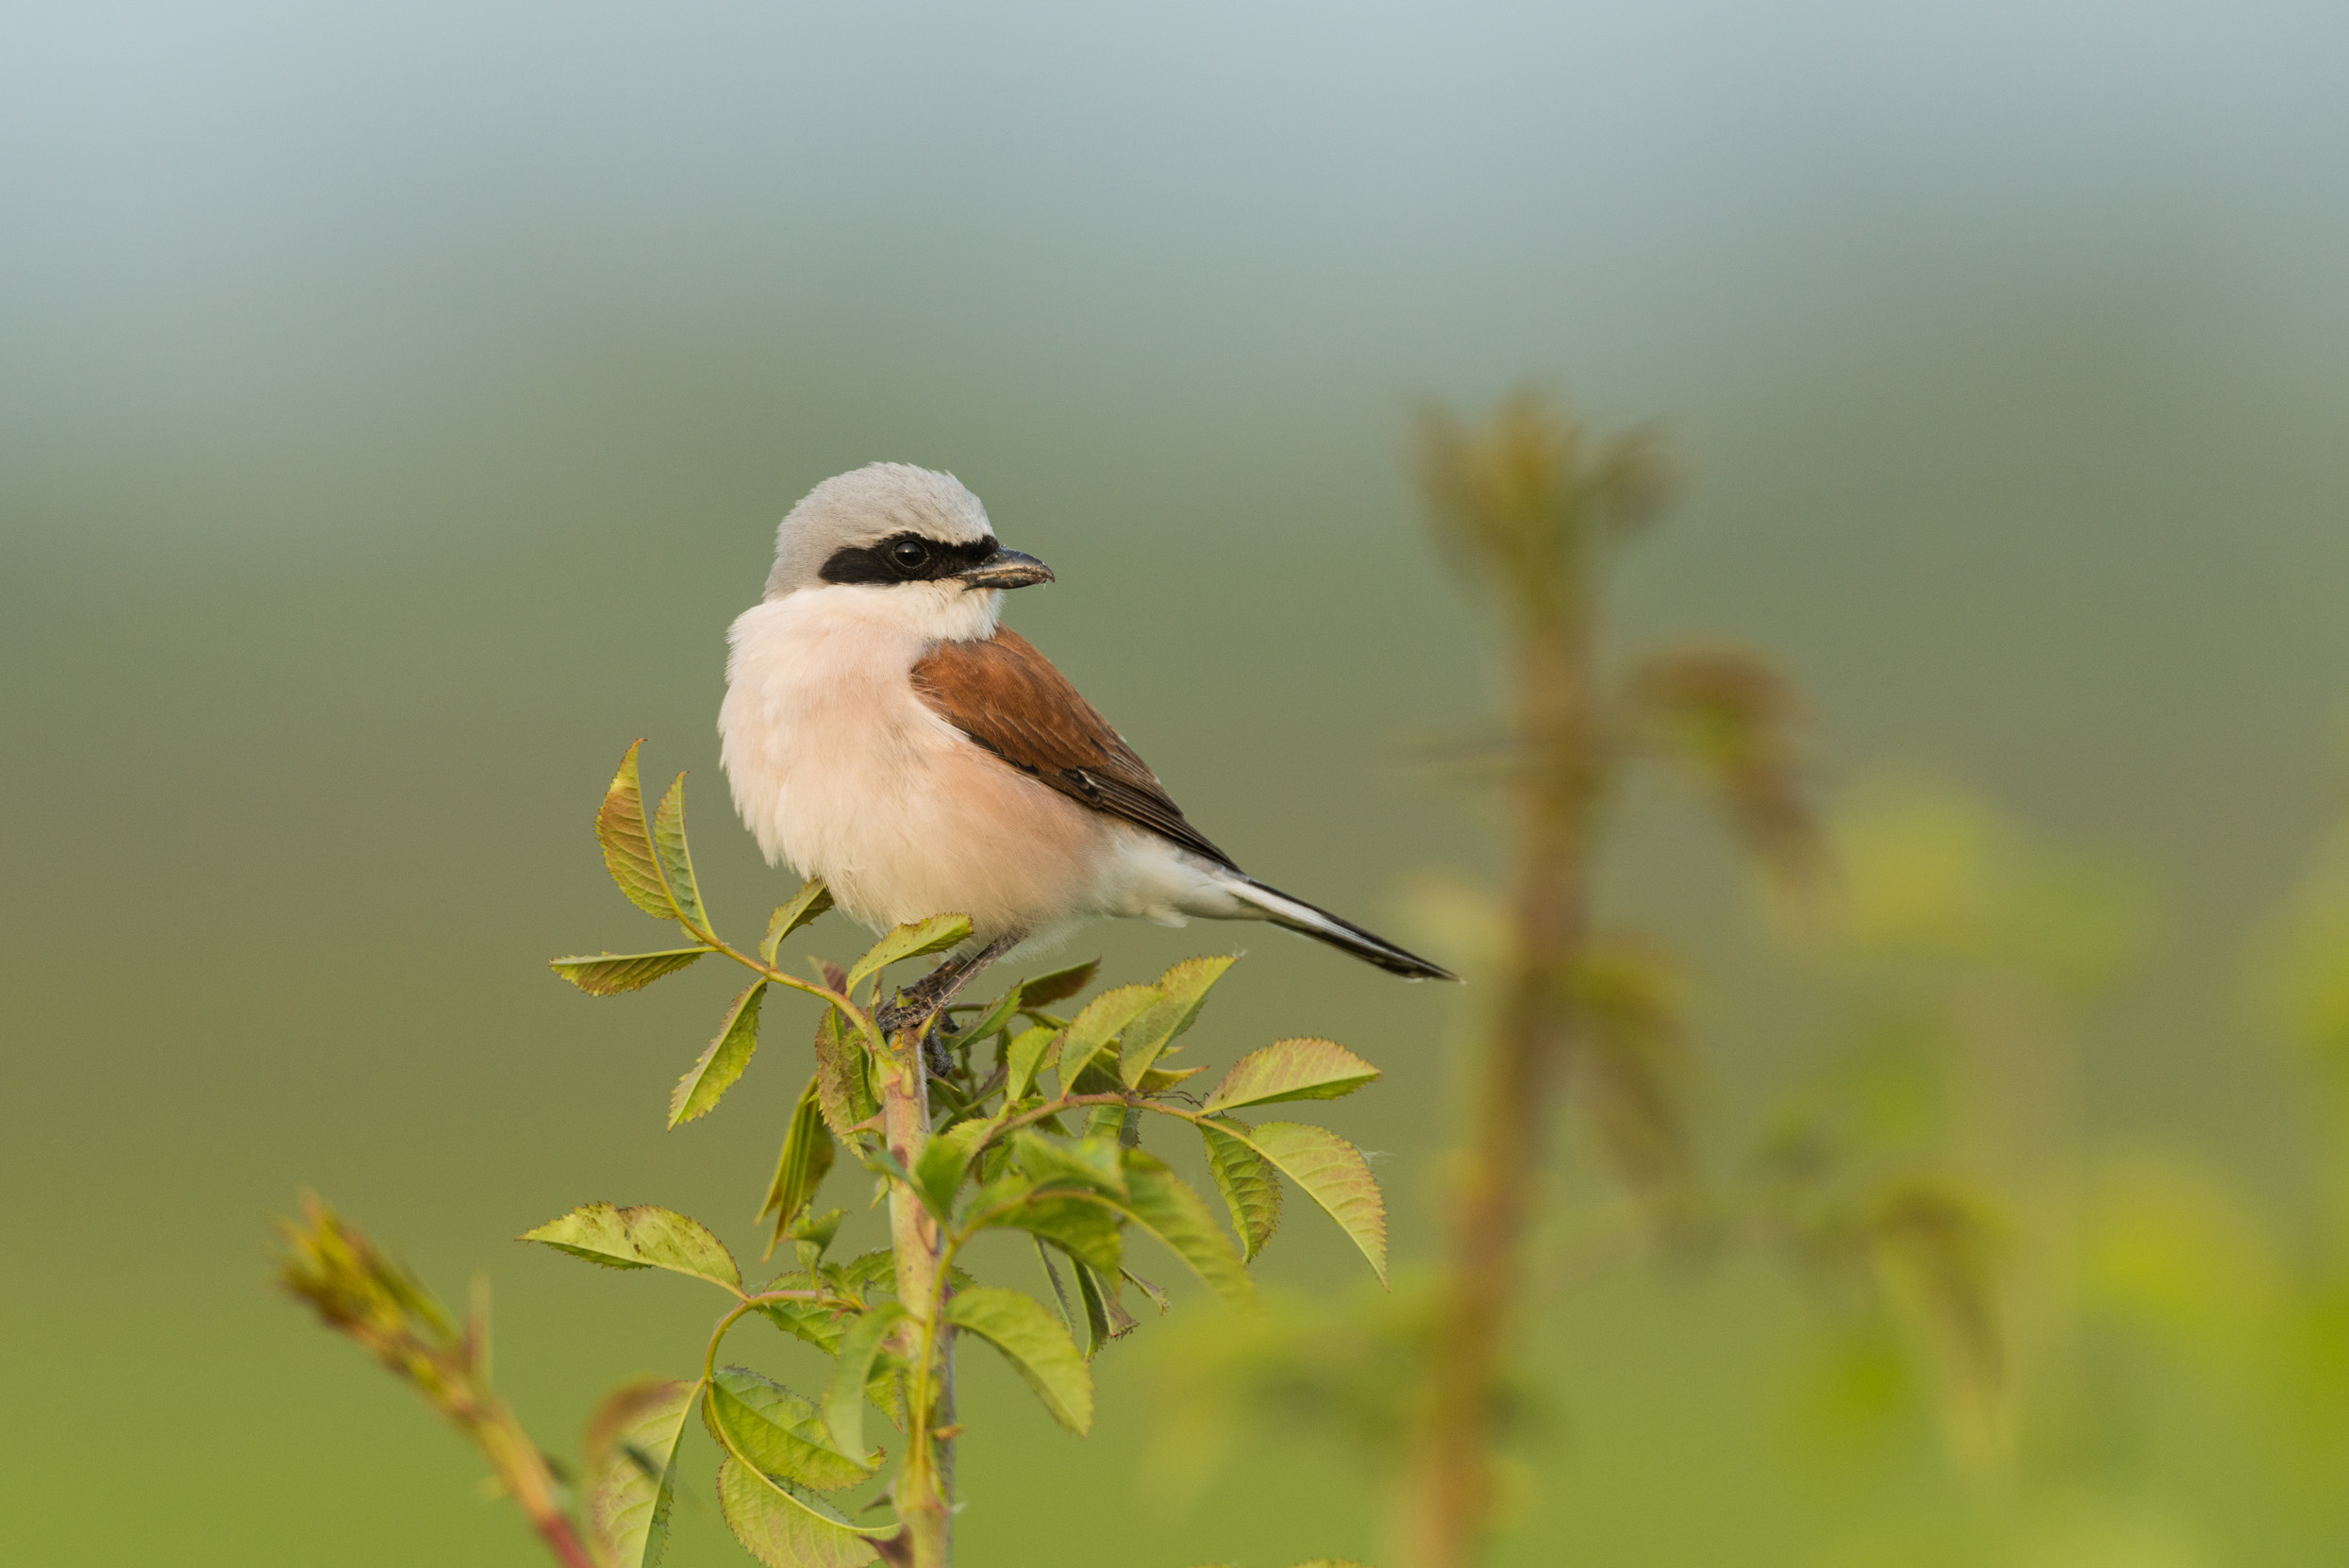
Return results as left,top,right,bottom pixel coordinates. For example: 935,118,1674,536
914,627,1238,870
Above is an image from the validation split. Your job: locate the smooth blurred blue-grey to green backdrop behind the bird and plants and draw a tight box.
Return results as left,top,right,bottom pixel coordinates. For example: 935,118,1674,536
0,0,2349,1568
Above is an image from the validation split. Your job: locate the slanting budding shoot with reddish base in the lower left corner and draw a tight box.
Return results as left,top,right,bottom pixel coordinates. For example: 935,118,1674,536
277,1199,596,1568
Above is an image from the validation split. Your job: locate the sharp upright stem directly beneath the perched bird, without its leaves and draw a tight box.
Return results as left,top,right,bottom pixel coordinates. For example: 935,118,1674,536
878,1025,954,1568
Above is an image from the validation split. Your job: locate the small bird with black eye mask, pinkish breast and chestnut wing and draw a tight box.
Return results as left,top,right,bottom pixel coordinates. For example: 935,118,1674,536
719,463,1458,1006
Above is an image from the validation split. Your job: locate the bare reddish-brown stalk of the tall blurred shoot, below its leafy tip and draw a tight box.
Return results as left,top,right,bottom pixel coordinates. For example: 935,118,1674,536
1408,594,1602,1568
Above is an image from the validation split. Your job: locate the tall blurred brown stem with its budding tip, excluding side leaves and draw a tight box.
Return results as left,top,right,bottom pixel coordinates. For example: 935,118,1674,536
1405,397,1660,1568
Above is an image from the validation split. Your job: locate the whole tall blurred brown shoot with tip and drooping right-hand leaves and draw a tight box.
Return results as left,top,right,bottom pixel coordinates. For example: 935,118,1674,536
1400,392,1816,1568
